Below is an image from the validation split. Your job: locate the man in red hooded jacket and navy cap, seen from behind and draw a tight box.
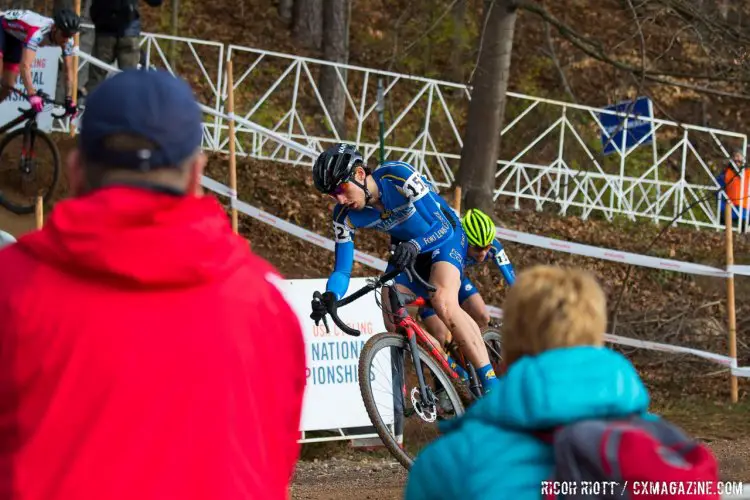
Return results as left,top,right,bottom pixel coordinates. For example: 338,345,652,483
0,70,305,500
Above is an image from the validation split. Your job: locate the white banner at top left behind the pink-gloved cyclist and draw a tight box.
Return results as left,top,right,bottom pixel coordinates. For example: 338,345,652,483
0,47,62,132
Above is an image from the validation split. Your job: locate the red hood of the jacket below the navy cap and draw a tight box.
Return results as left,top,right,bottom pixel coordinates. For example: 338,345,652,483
17,186,250,288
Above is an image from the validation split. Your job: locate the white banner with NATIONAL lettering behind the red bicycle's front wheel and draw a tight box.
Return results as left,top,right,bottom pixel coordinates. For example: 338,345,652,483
280,278,393,431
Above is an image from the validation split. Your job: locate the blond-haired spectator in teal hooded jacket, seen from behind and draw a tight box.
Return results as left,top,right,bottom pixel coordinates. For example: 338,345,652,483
405,268,649,500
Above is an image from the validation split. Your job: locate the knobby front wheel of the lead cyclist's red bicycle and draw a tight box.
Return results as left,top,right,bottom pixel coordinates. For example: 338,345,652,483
359,332,464,470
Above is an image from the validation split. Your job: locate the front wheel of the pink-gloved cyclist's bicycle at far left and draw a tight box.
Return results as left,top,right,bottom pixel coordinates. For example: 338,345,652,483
0,127,60,215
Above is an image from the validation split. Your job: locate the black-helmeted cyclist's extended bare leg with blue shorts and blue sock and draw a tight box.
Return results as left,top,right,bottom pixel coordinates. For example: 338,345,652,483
430,230,497,391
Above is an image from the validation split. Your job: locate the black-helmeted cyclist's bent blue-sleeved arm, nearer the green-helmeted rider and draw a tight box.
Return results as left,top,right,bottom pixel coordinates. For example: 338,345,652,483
382,164,453,253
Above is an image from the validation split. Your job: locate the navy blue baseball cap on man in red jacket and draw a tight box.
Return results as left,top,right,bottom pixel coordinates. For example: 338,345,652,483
78,69,203,171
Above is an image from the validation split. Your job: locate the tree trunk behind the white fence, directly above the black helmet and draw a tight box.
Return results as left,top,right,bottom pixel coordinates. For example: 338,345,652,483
318,0,351,138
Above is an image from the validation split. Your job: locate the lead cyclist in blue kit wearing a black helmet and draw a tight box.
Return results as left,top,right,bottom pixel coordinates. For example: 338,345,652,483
310,144,497,393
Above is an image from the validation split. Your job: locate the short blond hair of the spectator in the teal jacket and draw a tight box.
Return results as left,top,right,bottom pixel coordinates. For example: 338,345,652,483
503,266,607,365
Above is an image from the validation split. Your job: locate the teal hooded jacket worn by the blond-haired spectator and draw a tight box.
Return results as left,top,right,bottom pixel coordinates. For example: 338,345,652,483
405,346,649,500
